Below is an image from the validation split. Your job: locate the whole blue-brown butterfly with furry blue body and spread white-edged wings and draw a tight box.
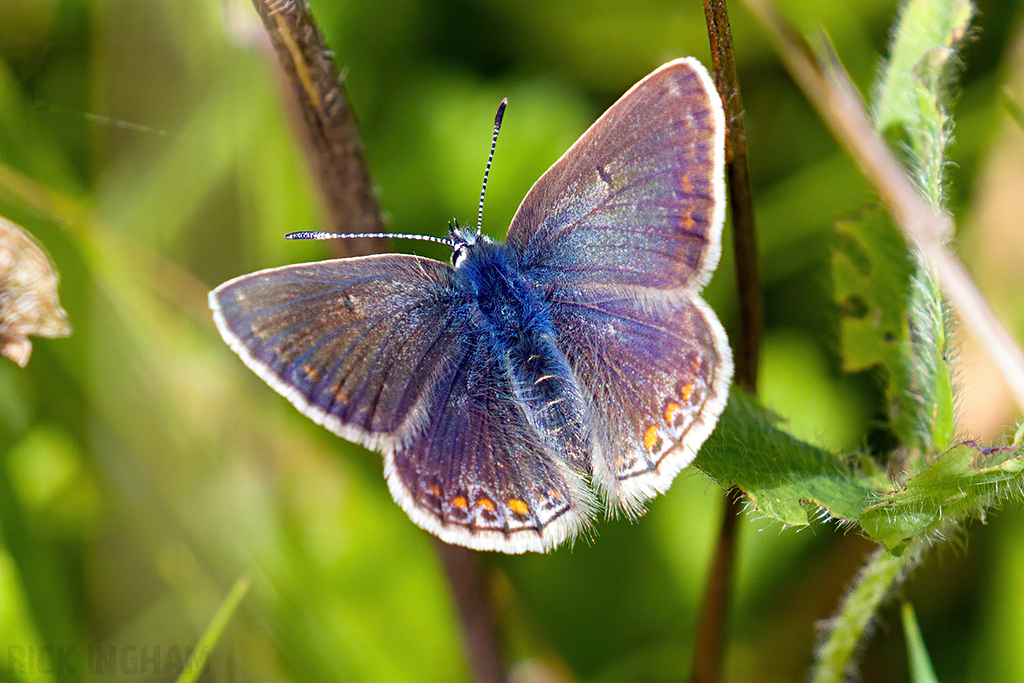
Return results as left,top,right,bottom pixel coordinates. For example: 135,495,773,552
210,58,732,553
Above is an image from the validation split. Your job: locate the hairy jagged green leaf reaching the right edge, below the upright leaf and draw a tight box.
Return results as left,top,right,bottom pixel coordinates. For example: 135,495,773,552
860,443,1024,548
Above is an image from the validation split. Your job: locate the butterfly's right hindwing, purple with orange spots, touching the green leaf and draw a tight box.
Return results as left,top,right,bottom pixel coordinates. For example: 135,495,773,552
553,288,732,514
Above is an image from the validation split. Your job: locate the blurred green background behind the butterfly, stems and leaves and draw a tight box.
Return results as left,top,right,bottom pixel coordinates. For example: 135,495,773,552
0,0,1024,681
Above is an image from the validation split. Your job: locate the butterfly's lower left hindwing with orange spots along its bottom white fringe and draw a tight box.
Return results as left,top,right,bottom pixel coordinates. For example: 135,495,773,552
384,327,595,553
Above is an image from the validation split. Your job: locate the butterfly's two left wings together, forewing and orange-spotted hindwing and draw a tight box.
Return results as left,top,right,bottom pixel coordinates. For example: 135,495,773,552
210,255,593,552
